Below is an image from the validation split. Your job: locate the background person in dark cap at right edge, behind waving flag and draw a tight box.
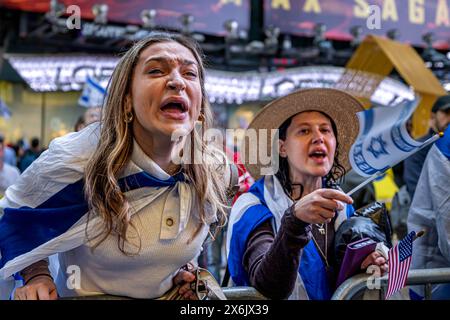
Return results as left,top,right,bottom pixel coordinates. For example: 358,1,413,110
403,95,450,199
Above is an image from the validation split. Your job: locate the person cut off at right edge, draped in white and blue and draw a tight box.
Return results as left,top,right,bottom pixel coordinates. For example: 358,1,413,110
408,124,450,300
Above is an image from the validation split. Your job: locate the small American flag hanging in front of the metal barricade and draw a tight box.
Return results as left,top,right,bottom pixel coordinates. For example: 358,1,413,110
385,231,416,300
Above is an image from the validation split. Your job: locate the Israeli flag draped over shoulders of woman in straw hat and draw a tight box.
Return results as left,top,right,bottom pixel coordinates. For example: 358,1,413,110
226,175,354,300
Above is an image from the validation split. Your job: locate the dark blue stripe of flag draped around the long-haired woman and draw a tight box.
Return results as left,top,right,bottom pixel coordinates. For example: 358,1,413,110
0,171,184,268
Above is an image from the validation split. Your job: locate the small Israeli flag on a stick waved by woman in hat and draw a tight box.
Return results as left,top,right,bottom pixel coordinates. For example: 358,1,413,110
349,99,425,177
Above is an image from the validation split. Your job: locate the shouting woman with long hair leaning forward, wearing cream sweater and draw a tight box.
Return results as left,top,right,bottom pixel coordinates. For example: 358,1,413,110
0,33,227,299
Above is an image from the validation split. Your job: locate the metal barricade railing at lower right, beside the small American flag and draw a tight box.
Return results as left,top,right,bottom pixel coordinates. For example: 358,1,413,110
331,268,450,300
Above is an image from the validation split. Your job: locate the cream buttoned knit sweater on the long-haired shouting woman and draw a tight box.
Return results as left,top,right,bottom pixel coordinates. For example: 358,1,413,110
56,142,212,298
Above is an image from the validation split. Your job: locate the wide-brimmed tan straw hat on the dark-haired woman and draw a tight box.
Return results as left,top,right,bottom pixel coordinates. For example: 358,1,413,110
241,88,364,180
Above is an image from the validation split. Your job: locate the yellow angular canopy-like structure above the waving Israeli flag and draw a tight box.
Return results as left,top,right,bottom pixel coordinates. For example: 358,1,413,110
346,35,447,137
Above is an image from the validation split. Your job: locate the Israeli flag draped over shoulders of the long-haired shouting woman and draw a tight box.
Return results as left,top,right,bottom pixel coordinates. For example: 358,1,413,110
0,122,193,285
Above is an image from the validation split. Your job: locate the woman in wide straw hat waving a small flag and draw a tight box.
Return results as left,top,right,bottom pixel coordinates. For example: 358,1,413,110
227,89,386,300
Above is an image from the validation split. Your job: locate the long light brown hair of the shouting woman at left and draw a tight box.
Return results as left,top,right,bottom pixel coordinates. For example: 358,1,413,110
84,33,227,255
